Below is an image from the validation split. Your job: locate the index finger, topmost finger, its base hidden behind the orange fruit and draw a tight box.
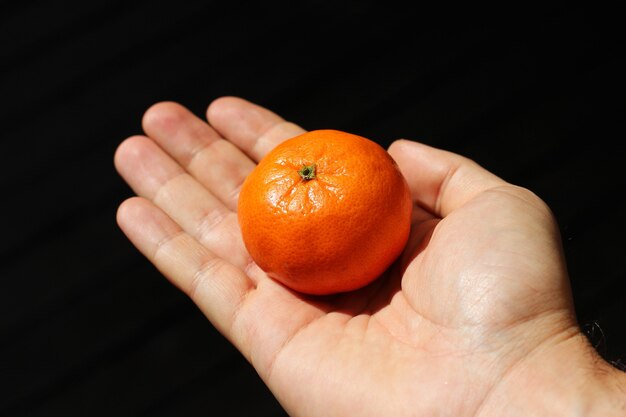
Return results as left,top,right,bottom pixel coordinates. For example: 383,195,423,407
207,97,304,161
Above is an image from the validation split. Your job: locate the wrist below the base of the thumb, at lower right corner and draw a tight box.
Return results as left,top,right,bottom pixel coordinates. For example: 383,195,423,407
479,329,626,417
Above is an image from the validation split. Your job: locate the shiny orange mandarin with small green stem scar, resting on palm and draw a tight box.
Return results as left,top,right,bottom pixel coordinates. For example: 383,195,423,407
238,129,412,295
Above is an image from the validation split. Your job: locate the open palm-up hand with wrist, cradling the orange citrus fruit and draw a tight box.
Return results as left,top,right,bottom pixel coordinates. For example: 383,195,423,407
115,97,626,417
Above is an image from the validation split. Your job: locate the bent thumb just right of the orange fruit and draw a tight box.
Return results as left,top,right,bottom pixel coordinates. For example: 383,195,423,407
389,140,506,217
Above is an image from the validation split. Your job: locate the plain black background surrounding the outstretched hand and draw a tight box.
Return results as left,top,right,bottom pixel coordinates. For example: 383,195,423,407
0,0,626,417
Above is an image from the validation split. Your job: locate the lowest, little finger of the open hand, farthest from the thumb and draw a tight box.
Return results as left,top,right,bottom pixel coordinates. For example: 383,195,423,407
117,197,254,342
